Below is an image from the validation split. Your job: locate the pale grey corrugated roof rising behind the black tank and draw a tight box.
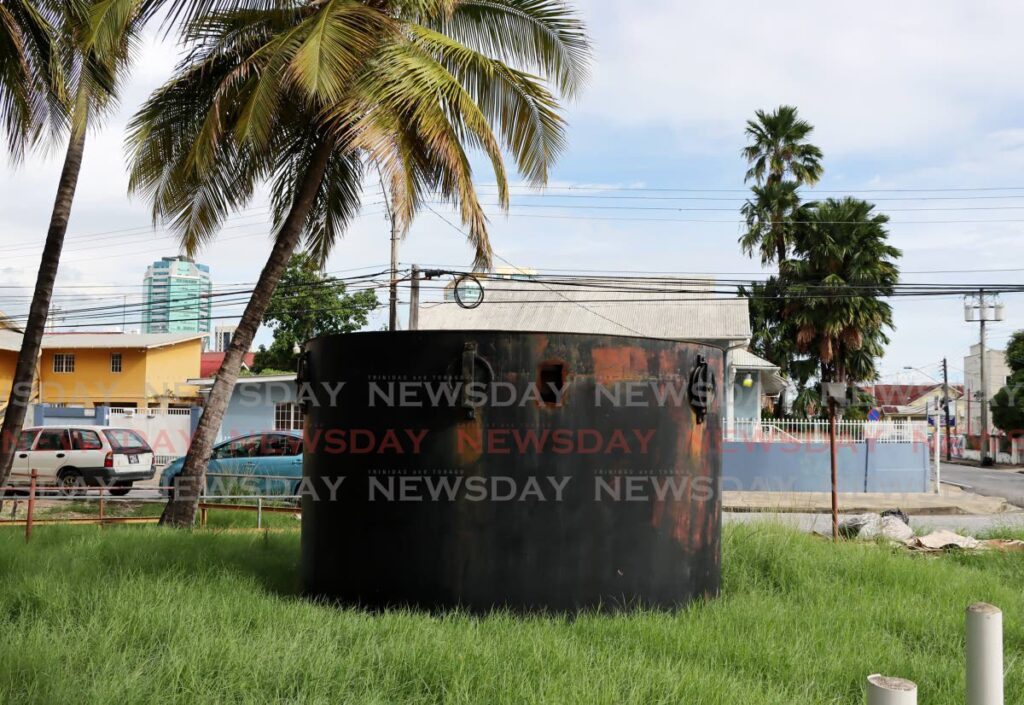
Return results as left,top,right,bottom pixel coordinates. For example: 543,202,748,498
420,279,751,341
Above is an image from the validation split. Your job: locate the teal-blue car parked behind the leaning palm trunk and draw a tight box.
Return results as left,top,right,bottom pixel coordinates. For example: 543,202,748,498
160,430,302,497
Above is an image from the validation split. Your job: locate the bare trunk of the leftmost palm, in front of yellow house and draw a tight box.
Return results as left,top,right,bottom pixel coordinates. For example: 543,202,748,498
0,120,86,486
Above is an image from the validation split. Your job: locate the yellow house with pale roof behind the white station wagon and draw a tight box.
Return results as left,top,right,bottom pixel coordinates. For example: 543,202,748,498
0,332,203,409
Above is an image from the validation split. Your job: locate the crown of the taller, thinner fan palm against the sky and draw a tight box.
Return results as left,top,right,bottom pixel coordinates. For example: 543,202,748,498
740,106,822,264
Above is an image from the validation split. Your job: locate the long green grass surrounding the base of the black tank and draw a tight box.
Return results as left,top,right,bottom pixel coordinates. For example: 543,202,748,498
0,525,1024,705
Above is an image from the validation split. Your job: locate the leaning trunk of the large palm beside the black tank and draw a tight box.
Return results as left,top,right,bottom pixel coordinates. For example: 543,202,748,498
160,138,334,527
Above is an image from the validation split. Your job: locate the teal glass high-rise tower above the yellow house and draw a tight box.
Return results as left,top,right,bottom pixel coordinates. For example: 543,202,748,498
142,256,213,333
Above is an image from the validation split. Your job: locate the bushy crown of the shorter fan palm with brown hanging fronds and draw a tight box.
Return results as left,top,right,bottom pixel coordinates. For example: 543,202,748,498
781,198,902,382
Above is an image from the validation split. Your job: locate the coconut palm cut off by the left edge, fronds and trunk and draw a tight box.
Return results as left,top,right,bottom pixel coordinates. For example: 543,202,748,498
0,0,141,485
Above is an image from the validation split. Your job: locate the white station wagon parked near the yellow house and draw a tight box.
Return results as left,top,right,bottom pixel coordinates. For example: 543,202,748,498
8,426,156,496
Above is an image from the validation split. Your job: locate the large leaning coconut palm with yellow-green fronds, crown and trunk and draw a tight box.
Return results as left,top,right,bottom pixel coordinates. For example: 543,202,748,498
129,0,589,526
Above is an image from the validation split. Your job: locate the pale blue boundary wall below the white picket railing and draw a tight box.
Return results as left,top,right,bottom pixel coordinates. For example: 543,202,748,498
722,441,930,492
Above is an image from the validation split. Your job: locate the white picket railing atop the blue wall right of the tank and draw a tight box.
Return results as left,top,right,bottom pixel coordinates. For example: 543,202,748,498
725,419,928,443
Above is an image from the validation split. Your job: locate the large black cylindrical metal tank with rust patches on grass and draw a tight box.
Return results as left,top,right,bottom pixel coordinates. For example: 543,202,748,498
299,331,723,611
